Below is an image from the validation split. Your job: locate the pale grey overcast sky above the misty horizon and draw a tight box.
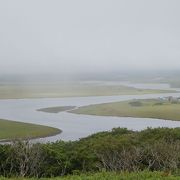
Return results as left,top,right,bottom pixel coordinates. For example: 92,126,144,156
0,0,180,73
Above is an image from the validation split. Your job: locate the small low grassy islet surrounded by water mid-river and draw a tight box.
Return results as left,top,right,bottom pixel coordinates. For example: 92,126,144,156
37,106,76,113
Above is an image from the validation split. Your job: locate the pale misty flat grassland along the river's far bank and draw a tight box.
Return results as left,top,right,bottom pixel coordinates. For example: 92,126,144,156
0,83,176,99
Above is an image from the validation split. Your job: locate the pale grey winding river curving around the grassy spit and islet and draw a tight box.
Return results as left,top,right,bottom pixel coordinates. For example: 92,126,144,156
0,83,180,142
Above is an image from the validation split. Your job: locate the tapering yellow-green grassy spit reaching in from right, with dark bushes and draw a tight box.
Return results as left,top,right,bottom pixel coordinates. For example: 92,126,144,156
70,99,180,121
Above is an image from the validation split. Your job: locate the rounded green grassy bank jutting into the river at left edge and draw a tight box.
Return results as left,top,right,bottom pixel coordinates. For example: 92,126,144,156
0,119,61,141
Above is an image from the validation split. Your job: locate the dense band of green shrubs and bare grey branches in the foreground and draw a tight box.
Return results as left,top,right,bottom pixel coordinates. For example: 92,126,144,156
0,128,180,177
